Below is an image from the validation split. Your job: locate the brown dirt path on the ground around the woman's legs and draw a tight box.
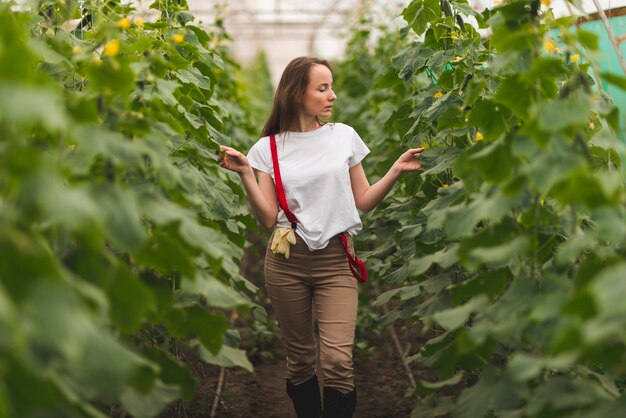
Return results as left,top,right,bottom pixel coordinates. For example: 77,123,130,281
173,335,419,418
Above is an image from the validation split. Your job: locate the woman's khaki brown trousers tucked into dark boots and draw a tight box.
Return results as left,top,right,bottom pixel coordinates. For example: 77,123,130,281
265,234,358,393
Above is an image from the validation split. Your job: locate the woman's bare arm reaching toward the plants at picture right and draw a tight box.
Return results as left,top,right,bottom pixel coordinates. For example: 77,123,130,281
350,148,424,213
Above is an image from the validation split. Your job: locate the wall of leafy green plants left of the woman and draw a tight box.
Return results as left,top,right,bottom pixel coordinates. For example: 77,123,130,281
0,1,256,417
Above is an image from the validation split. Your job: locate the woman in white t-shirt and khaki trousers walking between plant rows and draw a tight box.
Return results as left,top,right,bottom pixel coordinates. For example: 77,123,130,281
218,57,423,417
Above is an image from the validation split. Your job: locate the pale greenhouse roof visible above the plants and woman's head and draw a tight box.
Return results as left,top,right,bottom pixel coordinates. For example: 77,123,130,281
183,0,626,82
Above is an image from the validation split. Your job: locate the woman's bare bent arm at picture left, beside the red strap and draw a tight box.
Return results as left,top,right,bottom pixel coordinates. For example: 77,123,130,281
217,145,278,228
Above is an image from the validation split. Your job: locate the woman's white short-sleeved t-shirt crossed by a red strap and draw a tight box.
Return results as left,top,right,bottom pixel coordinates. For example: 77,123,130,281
248,123,369,250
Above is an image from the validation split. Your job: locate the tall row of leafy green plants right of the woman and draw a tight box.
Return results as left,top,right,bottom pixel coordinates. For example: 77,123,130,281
337,0,626,418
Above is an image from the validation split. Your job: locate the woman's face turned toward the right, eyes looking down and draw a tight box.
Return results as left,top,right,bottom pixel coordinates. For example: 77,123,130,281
302,64,337,118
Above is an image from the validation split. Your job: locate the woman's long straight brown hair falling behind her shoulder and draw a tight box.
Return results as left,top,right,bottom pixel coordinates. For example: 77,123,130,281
261,57,333,137
